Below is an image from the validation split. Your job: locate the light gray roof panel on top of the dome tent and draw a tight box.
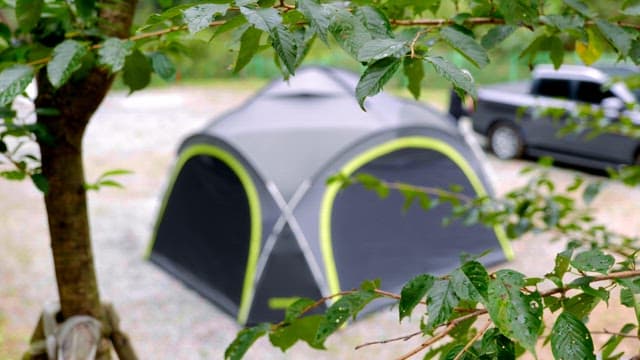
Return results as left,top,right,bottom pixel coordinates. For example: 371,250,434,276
194,67,458,199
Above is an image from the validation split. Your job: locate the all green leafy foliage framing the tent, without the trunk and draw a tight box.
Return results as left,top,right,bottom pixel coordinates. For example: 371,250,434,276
0,0,640,359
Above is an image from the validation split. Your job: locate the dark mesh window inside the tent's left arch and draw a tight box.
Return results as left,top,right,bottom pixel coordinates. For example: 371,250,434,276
154,155,251,304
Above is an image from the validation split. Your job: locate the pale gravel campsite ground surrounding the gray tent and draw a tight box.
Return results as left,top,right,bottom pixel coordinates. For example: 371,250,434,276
0,83,640,359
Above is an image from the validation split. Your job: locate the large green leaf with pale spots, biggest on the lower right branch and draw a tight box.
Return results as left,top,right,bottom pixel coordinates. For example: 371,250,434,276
487,270,543,354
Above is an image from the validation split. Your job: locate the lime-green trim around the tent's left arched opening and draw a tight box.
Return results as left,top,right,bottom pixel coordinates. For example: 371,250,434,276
146,144,262,324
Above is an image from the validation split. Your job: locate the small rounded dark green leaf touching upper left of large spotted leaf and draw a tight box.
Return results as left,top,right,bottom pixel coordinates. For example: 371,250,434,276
451,261,489,304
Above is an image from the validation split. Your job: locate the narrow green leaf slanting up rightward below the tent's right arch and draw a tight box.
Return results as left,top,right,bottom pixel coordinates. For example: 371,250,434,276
313,290,380,346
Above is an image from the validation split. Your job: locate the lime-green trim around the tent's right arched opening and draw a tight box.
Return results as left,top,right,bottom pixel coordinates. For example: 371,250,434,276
319,136,514,294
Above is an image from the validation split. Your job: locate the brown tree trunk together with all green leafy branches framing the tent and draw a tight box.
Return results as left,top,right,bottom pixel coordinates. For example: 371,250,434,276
0,0,640,358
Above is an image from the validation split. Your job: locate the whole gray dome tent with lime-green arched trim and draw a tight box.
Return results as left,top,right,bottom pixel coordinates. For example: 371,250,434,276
150,67,511,324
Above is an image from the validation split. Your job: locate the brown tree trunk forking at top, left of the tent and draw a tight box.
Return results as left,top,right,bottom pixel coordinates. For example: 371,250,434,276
35,0,136,358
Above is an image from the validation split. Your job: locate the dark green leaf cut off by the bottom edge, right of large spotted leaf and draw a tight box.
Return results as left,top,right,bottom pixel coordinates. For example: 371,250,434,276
551,312,596,360
